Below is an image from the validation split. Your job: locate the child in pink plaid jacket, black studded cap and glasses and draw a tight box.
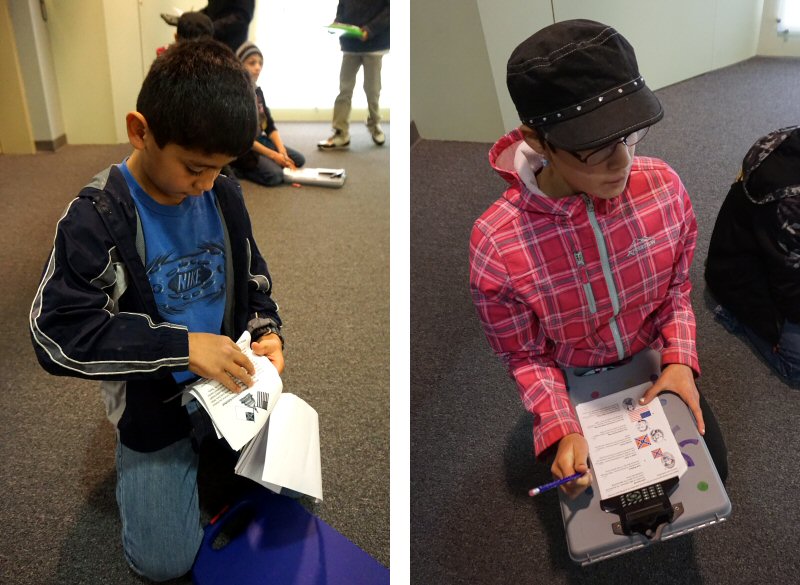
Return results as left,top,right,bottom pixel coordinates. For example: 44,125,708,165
470,20,727,497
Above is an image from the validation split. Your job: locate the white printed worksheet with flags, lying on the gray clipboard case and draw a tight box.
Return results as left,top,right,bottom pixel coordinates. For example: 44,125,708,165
575,383,687,499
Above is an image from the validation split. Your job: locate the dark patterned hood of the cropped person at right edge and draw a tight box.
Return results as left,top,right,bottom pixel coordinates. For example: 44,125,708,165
738,126,800,204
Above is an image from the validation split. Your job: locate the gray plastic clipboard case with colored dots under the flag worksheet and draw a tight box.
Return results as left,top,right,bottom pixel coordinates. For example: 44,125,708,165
558,350,731,565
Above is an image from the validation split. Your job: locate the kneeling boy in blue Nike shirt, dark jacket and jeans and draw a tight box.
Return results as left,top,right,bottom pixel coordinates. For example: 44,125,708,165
30,40,283,581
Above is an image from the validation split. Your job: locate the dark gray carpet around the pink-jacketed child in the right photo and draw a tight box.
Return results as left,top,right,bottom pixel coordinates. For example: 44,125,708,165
410,58,800,585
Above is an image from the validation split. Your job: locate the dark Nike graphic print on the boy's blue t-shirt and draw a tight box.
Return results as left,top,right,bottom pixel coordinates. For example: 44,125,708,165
147,242,225,315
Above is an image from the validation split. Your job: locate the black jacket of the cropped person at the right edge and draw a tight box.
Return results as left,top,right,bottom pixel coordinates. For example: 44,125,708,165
705,127,800,344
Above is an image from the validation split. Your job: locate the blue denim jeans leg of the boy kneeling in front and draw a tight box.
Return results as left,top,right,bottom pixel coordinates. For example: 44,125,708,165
117,439,203,581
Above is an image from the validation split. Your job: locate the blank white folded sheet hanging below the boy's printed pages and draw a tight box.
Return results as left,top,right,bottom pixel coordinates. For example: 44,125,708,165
236,393,322,502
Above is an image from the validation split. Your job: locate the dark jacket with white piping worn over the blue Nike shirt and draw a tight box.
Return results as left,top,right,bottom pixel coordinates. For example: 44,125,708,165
30,166,280,451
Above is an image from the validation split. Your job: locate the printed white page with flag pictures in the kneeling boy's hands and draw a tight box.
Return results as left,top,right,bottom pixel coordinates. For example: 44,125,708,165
187,331,283,451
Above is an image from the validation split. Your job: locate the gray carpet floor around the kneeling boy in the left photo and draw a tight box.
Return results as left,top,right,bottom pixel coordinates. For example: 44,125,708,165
0,123,390,585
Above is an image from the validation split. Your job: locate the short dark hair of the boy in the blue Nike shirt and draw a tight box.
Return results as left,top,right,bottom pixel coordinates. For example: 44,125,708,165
136,39,258,157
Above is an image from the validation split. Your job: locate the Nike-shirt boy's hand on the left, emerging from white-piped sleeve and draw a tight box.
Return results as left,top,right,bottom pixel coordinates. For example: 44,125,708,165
189,333,256,394
